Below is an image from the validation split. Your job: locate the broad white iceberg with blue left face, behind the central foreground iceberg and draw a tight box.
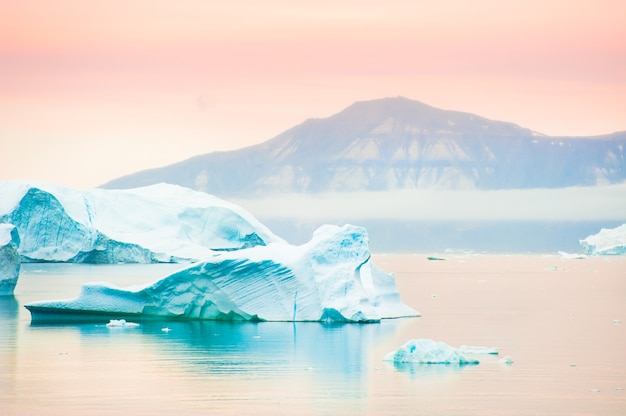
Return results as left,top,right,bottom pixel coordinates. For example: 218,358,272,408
0,181,282,263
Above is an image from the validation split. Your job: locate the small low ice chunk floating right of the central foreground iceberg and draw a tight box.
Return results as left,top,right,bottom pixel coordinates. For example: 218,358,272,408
384,339,480,365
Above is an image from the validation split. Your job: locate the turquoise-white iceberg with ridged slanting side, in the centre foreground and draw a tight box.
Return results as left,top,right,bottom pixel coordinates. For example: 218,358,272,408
26,225,419,322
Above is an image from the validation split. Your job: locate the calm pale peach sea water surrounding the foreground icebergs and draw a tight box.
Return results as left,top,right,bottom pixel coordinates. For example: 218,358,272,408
0,254,626,415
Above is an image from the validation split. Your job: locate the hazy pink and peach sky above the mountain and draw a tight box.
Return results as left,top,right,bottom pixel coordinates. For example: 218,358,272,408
0,0,626,187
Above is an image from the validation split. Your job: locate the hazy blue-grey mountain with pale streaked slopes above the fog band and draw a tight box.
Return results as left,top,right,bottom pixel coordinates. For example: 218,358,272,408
102,97,626,196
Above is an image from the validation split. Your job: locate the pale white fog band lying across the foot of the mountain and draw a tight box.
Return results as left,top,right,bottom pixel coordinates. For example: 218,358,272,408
232,184,626,223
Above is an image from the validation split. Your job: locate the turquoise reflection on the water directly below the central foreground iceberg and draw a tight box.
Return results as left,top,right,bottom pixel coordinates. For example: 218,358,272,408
63,321,395,380
